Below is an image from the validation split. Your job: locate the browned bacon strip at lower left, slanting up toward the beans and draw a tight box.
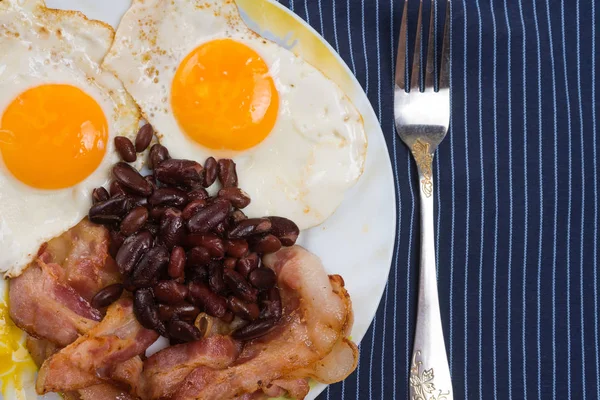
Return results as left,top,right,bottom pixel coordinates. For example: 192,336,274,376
36,298,158,394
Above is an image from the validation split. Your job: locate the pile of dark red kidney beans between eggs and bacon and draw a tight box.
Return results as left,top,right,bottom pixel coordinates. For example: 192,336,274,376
89,125,299,343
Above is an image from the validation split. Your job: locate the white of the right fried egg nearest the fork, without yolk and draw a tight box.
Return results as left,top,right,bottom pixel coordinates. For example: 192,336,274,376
104,0,367,229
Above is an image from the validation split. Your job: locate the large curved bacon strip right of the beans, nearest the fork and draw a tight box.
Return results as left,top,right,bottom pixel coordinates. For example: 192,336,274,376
173,246,352,400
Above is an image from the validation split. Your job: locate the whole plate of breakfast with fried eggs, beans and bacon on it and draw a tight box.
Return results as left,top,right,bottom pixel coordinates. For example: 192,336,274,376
0,0,396,400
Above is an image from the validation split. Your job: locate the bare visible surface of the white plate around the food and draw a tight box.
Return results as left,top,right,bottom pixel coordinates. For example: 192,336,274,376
0,0,396,399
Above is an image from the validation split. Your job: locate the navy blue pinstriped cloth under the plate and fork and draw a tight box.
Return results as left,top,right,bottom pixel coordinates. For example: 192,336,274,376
281,0,600,400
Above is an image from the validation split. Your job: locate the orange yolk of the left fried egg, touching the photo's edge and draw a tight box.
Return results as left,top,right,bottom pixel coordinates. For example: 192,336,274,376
0,84,108,189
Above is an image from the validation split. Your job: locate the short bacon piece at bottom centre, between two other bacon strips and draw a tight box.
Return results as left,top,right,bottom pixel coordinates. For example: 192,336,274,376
144,335,240,399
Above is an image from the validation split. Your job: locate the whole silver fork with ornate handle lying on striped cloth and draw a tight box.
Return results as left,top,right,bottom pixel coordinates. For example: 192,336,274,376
394,0,454,400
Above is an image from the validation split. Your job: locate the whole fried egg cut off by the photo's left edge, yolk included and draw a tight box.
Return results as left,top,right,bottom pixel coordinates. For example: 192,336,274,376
0,0,139,276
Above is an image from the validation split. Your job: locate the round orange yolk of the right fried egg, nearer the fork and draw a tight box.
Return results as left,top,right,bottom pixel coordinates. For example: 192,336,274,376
171,39,279,150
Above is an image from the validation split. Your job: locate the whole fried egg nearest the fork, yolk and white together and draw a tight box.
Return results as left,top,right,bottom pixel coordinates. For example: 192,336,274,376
104,0,367,229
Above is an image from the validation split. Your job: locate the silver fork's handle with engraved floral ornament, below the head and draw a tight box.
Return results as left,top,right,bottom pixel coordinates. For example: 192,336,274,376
409,160,454,400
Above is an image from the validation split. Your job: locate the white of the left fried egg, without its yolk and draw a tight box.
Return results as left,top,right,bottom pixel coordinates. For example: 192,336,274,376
0,0,139,277
